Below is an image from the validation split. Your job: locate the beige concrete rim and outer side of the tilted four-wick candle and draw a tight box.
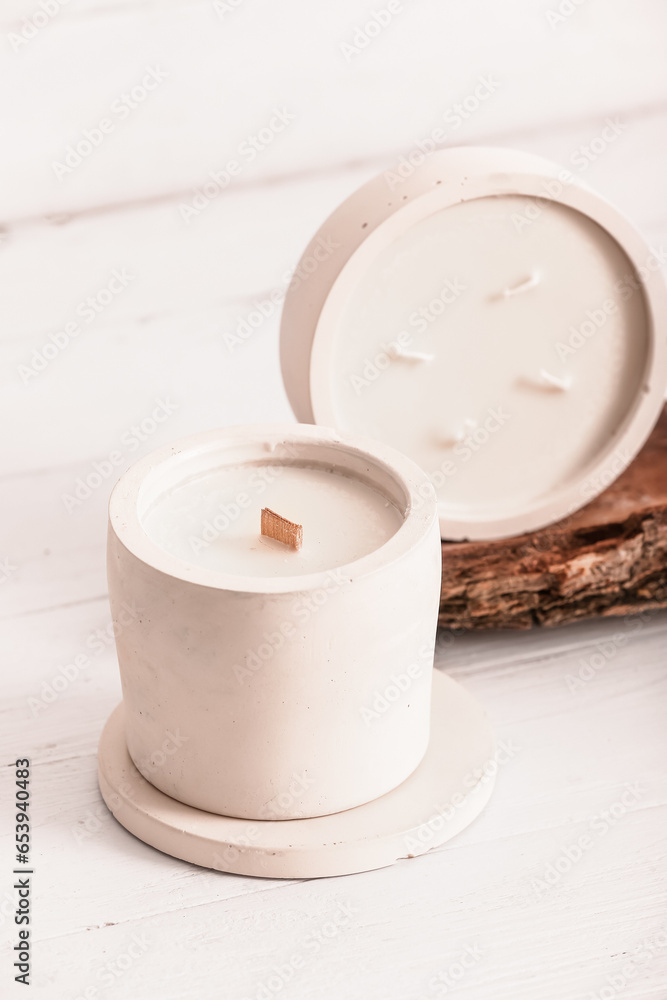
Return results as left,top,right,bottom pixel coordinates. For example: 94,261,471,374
280,146,667,540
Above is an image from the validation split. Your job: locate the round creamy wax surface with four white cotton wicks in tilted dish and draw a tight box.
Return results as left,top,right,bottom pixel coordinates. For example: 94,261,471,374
330,195,648,518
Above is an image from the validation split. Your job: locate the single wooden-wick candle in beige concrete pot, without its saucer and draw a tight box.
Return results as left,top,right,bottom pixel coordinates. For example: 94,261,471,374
101,426,440,820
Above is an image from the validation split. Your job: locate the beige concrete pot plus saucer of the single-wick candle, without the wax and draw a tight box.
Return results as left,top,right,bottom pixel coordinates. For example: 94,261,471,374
99,426,493,877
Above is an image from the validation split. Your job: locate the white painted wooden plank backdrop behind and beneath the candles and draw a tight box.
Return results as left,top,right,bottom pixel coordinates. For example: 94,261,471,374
0,0,667,1000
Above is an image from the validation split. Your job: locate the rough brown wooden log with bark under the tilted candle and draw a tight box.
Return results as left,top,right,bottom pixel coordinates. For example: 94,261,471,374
439,406,667,629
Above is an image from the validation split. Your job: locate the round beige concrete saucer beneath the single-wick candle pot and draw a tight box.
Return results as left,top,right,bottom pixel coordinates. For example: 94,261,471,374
98,671,497,878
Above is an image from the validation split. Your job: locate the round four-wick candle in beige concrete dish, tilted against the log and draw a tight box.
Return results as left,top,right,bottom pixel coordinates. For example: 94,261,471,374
281,149,667,538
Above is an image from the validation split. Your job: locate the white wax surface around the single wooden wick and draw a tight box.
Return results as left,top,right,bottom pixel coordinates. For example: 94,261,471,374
142,463,403,576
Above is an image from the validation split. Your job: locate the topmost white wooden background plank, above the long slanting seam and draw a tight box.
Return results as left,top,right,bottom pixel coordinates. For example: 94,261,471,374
0,0,666,219
